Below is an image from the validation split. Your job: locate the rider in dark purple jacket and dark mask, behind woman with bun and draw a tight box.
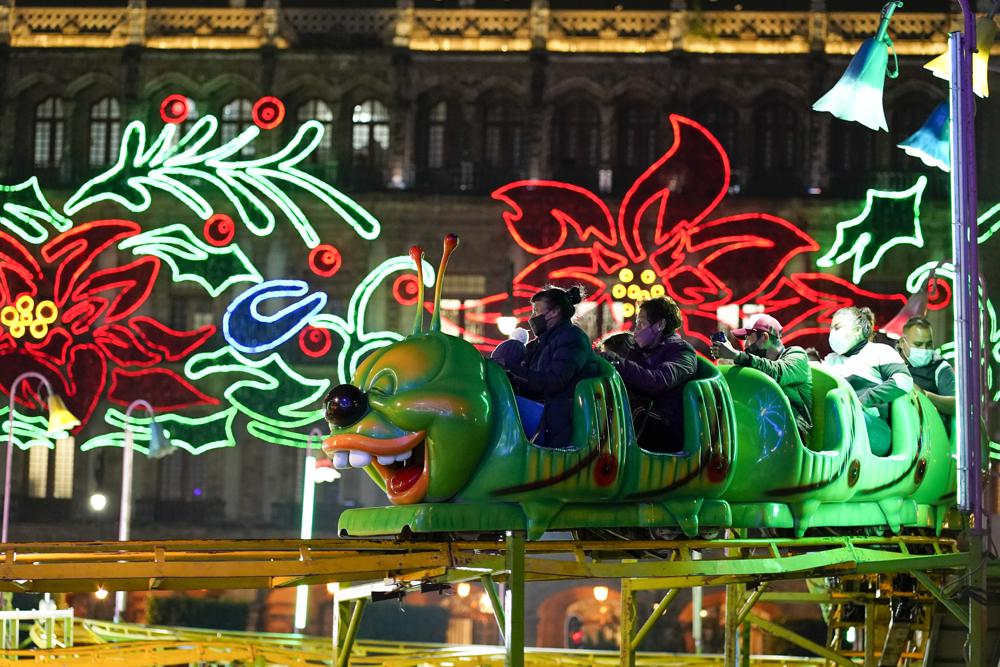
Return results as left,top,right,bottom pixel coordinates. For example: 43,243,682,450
602,297,697,452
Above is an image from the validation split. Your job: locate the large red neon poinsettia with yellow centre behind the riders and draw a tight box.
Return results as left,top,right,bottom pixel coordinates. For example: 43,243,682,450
428,115,905,345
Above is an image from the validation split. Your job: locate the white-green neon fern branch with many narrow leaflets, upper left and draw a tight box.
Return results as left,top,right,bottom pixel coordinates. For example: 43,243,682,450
64,116,381,248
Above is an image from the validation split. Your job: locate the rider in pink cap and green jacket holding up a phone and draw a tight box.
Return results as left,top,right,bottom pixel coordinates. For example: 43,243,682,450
712,315,813,444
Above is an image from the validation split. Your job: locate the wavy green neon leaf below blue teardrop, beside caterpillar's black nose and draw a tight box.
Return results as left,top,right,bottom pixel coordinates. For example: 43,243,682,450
184,346,330,430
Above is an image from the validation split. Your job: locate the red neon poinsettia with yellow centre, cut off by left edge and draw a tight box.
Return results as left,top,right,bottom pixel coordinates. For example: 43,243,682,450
0,220,218,424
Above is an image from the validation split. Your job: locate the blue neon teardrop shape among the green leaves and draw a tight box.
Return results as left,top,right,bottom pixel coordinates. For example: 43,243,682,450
222,280,326,354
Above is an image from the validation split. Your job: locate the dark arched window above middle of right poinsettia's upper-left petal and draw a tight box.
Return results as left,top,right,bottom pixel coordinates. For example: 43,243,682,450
552,100,601,181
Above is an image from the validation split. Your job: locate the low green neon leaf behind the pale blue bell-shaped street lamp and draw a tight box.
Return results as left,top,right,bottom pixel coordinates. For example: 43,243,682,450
80,407,238,456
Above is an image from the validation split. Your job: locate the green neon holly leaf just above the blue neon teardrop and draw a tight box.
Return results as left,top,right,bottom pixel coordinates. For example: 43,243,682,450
119,224,263,296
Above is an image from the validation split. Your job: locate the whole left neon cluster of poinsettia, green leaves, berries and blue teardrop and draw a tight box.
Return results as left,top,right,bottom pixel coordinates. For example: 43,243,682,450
0,95,414,454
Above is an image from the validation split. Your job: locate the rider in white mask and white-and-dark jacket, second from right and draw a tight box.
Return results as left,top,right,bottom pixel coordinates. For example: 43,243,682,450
823,307,913,456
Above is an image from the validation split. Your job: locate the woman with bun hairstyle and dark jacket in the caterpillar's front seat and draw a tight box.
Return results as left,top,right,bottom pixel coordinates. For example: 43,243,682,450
506,286,599,449
